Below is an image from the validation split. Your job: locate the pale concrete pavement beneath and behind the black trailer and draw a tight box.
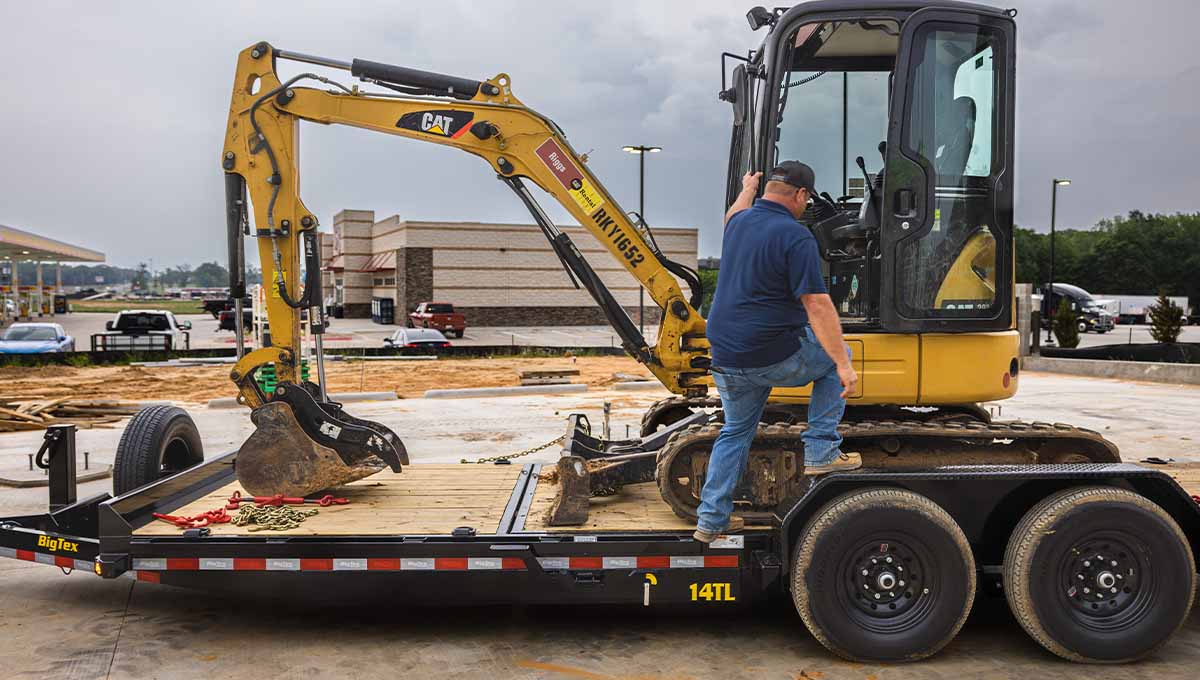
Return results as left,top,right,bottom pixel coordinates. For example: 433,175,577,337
0,373,1200,680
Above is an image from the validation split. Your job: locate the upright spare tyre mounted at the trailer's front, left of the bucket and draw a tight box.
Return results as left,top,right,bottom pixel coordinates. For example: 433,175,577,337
113,405,204,495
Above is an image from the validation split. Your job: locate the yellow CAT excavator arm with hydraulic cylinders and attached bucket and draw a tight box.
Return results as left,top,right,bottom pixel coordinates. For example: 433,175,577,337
222,42,709,493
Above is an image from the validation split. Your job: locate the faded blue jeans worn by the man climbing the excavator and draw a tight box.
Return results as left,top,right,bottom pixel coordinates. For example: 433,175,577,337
697,327,850,534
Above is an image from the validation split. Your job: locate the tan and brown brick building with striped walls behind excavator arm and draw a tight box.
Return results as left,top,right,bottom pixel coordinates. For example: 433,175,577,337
322,210,698,326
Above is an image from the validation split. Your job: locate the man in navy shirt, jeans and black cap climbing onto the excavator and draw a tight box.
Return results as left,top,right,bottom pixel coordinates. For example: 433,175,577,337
695,161,863,543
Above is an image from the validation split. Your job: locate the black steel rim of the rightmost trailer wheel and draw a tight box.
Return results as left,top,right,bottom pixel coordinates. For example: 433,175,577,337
1056,530,1159,632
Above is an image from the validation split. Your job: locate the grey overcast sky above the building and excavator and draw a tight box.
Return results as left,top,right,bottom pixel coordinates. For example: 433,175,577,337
0,0,1200,267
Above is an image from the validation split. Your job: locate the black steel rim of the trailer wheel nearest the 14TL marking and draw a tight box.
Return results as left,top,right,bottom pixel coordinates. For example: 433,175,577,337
836,531,942,634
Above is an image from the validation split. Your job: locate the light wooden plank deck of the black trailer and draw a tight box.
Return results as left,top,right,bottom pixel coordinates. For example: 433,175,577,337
134,463,1200,536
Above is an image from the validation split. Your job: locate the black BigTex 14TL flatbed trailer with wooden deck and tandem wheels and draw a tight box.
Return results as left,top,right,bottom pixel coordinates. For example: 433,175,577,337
0,414,1200,662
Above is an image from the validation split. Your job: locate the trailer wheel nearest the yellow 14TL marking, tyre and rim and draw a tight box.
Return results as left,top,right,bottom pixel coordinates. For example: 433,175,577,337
792,488,976,662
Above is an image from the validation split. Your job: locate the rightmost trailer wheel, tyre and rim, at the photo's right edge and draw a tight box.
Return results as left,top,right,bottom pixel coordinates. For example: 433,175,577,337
1004,487,1196,663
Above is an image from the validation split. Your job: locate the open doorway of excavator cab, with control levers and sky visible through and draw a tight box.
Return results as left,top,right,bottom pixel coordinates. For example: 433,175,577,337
764,18,900,323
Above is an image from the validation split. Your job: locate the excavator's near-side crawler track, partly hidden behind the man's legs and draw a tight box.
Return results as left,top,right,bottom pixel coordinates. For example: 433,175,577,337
655,420,1121,519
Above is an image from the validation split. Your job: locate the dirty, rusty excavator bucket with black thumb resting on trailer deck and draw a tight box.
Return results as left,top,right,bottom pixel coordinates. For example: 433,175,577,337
235,384,408,495
